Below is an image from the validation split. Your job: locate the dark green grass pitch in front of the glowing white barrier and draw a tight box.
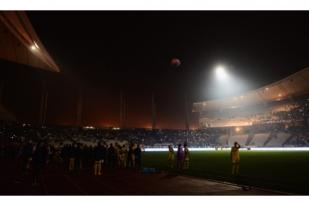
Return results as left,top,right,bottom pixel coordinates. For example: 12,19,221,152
143,151,309,194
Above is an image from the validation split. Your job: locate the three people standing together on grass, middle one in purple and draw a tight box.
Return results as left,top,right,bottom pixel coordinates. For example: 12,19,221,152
168,143,190,170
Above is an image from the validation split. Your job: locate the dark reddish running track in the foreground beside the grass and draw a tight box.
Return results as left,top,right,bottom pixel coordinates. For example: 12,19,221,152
0,160,280,195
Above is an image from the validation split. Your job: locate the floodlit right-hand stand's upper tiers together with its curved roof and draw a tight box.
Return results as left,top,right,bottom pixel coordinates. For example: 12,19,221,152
193,67,309,129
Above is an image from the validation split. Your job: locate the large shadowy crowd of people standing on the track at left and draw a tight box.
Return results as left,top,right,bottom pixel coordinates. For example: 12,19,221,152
1,141,142,185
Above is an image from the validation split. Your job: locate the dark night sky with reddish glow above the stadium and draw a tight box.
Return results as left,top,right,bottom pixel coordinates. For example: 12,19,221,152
3,11,309,128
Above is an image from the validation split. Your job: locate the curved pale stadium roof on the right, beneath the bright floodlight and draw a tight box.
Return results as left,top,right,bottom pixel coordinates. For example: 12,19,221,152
193,67,309,112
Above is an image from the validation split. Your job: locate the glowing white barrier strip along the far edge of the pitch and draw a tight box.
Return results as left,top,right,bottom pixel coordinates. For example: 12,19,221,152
145,147,309,152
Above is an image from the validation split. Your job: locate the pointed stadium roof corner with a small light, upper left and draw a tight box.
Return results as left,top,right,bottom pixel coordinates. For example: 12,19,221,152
0,11,60,72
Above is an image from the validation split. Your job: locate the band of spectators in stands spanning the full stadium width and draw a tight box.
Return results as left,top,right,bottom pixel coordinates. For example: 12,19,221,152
0,118,309,154
